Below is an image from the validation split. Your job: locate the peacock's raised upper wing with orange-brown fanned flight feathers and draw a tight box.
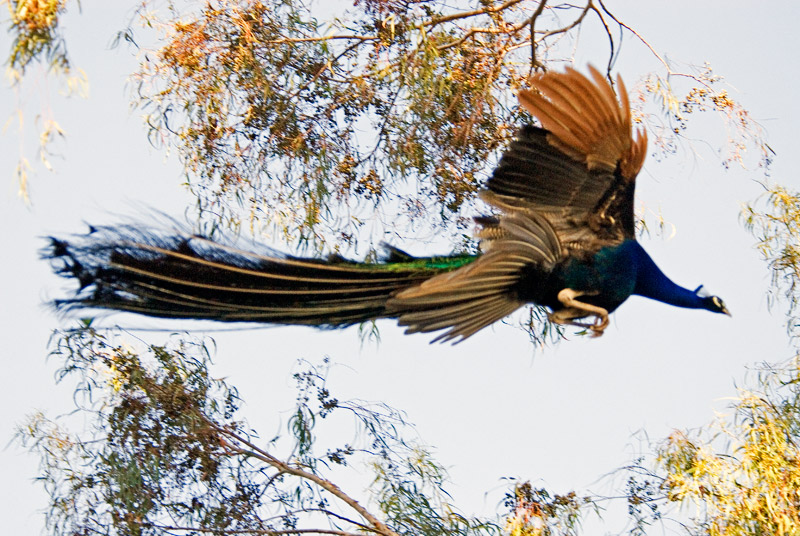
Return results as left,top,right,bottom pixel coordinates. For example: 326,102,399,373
483,66,647,242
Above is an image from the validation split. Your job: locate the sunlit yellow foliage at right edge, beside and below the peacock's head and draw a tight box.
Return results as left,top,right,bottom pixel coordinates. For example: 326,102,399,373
616,185,800,536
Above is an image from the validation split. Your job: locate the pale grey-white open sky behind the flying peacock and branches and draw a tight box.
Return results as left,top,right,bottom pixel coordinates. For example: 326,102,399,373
0,0,800,535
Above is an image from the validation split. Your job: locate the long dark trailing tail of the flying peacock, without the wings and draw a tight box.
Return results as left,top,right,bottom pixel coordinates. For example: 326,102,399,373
44,226,474,327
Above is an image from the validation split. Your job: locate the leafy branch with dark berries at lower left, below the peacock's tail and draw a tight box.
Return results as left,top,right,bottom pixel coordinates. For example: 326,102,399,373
19,326,496,536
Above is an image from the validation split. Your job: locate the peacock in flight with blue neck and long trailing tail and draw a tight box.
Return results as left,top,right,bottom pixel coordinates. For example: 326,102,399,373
45,67,730,342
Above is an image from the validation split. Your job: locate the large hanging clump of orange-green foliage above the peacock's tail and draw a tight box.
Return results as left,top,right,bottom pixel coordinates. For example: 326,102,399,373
130,0,624,244
